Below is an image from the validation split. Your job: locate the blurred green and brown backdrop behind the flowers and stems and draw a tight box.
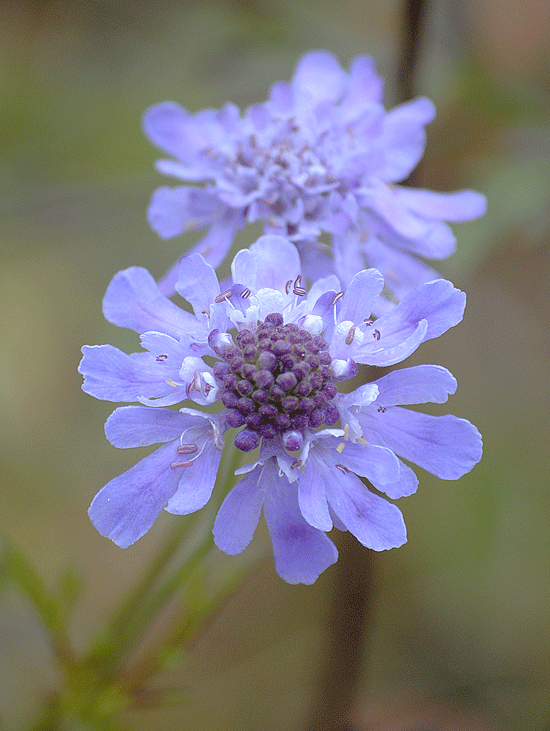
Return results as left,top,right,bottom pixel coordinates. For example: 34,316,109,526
0,0,550,731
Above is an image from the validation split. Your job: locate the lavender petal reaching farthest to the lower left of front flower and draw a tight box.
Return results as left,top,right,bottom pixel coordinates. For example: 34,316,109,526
88,442,180,548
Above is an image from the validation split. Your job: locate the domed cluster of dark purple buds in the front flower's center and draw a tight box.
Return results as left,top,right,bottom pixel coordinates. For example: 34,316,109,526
214,313,340,452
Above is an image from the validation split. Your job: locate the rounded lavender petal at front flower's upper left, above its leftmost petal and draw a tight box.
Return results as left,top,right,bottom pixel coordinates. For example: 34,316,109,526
103,267,202,339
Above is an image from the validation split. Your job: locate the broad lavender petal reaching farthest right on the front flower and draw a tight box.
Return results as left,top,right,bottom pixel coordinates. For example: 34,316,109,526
359,406,482,480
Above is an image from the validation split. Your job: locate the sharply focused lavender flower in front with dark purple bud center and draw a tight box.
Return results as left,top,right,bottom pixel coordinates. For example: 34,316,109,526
79,235,481,584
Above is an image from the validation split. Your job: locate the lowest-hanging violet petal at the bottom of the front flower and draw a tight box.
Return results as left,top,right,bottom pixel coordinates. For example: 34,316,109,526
261,460,338,584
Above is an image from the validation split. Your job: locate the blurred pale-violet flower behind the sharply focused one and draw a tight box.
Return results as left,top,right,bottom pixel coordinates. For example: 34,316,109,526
143,51,485,307
